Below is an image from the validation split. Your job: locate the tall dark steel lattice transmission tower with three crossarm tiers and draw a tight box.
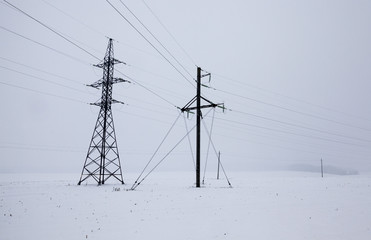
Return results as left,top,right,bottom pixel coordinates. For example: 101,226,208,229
78,39,128,185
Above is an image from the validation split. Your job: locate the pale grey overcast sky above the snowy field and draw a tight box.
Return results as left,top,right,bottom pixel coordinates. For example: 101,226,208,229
0,0,371,175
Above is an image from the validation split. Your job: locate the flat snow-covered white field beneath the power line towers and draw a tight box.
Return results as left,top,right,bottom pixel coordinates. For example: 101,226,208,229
0,172,371,240
